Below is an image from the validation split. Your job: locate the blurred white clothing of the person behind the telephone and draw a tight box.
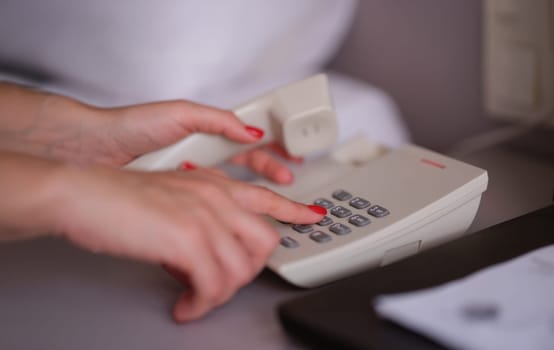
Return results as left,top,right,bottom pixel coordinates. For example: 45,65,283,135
0,0,406,143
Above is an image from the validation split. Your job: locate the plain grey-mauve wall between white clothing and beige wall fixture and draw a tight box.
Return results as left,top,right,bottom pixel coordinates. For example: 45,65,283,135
331,0,495,150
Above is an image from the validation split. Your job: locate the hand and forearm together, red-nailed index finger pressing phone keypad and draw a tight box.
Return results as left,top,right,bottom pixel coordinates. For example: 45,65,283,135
0,152,324,322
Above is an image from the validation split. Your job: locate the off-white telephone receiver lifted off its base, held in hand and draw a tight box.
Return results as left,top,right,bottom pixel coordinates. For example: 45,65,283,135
126,74,338,171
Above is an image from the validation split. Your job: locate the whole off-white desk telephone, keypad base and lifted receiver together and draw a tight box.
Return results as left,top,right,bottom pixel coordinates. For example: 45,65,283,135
127,74,488,287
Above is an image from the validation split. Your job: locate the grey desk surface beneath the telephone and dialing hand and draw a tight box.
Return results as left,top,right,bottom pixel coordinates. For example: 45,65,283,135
0,149,554,350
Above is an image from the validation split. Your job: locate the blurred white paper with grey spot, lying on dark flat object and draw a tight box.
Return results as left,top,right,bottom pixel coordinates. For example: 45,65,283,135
374,245,554,350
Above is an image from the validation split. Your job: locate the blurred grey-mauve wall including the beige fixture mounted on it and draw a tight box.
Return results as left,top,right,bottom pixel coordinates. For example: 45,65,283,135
330,0,554,157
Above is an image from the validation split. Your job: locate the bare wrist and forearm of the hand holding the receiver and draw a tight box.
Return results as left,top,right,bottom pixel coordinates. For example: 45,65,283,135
0,82,108,163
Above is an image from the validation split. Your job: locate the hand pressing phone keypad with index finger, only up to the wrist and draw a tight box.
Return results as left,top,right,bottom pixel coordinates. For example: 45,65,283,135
59,164,322,322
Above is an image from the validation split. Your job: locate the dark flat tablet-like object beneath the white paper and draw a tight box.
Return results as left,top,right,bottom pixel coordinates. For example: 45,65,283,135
277,205,554,349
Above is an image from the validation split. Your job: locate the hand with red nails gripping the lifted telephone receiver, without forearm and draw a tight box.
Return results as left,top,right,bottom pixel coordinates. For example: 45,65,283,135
98,101,299,184
